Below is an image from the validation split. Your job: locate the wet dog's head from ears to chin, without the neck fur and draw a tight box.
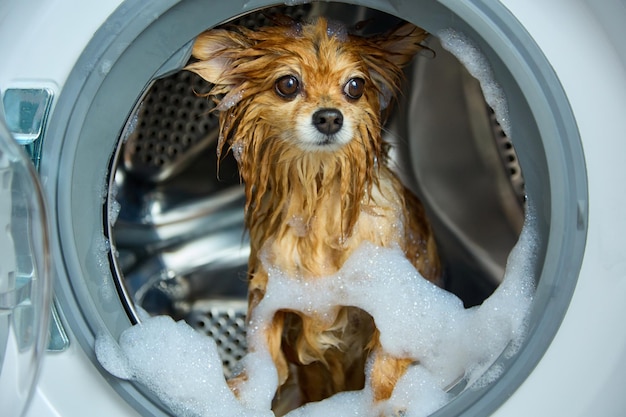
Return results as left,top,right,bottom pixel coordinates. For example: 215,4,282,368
187,18,426,156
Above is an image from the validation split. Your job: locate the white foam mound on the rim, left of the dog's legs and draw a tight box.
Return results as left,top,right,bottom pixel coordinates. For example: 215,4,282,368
96,316,274,417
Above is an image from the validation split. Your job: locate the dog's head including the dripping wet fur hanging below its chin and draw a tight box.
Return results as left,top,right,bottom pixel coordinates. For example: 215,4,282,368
187,18,427,237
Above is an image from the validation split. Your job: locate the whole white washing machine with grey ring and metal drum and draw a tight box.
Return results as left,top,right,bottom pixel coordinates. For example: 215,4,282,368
0,0,626,417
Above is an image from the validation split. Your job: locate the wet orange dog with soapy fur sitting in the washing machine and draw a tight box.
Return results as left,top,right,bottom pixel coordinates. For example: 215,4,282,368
187,18,440,412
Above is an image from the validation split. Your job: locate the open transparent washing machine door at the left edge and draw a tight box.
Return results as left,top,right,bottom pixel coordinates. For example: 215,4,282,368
0,113,51,417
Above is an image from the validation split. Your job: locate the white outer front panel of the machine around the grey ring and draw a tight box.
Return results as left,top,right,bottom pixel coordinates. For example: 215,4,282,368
0,0,626,417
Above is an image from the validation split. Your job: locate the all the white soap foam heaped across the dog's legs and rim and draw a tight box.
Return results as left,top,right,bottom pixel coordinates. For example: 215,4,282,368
96,211,536,417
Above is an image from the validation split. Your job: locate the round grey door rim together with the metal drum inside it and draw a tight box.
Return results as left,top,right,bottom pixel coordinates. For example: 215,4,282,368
33,0,604,415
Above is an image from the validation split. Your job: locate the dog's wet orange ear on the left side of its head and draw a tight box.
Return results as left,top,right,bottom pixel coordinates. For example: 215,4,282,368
185,29,250,86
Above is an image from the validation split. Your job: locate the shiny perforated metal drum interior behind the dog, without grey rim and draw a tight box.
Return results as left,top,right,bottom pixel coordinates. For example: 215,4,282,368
107,3,525,384
